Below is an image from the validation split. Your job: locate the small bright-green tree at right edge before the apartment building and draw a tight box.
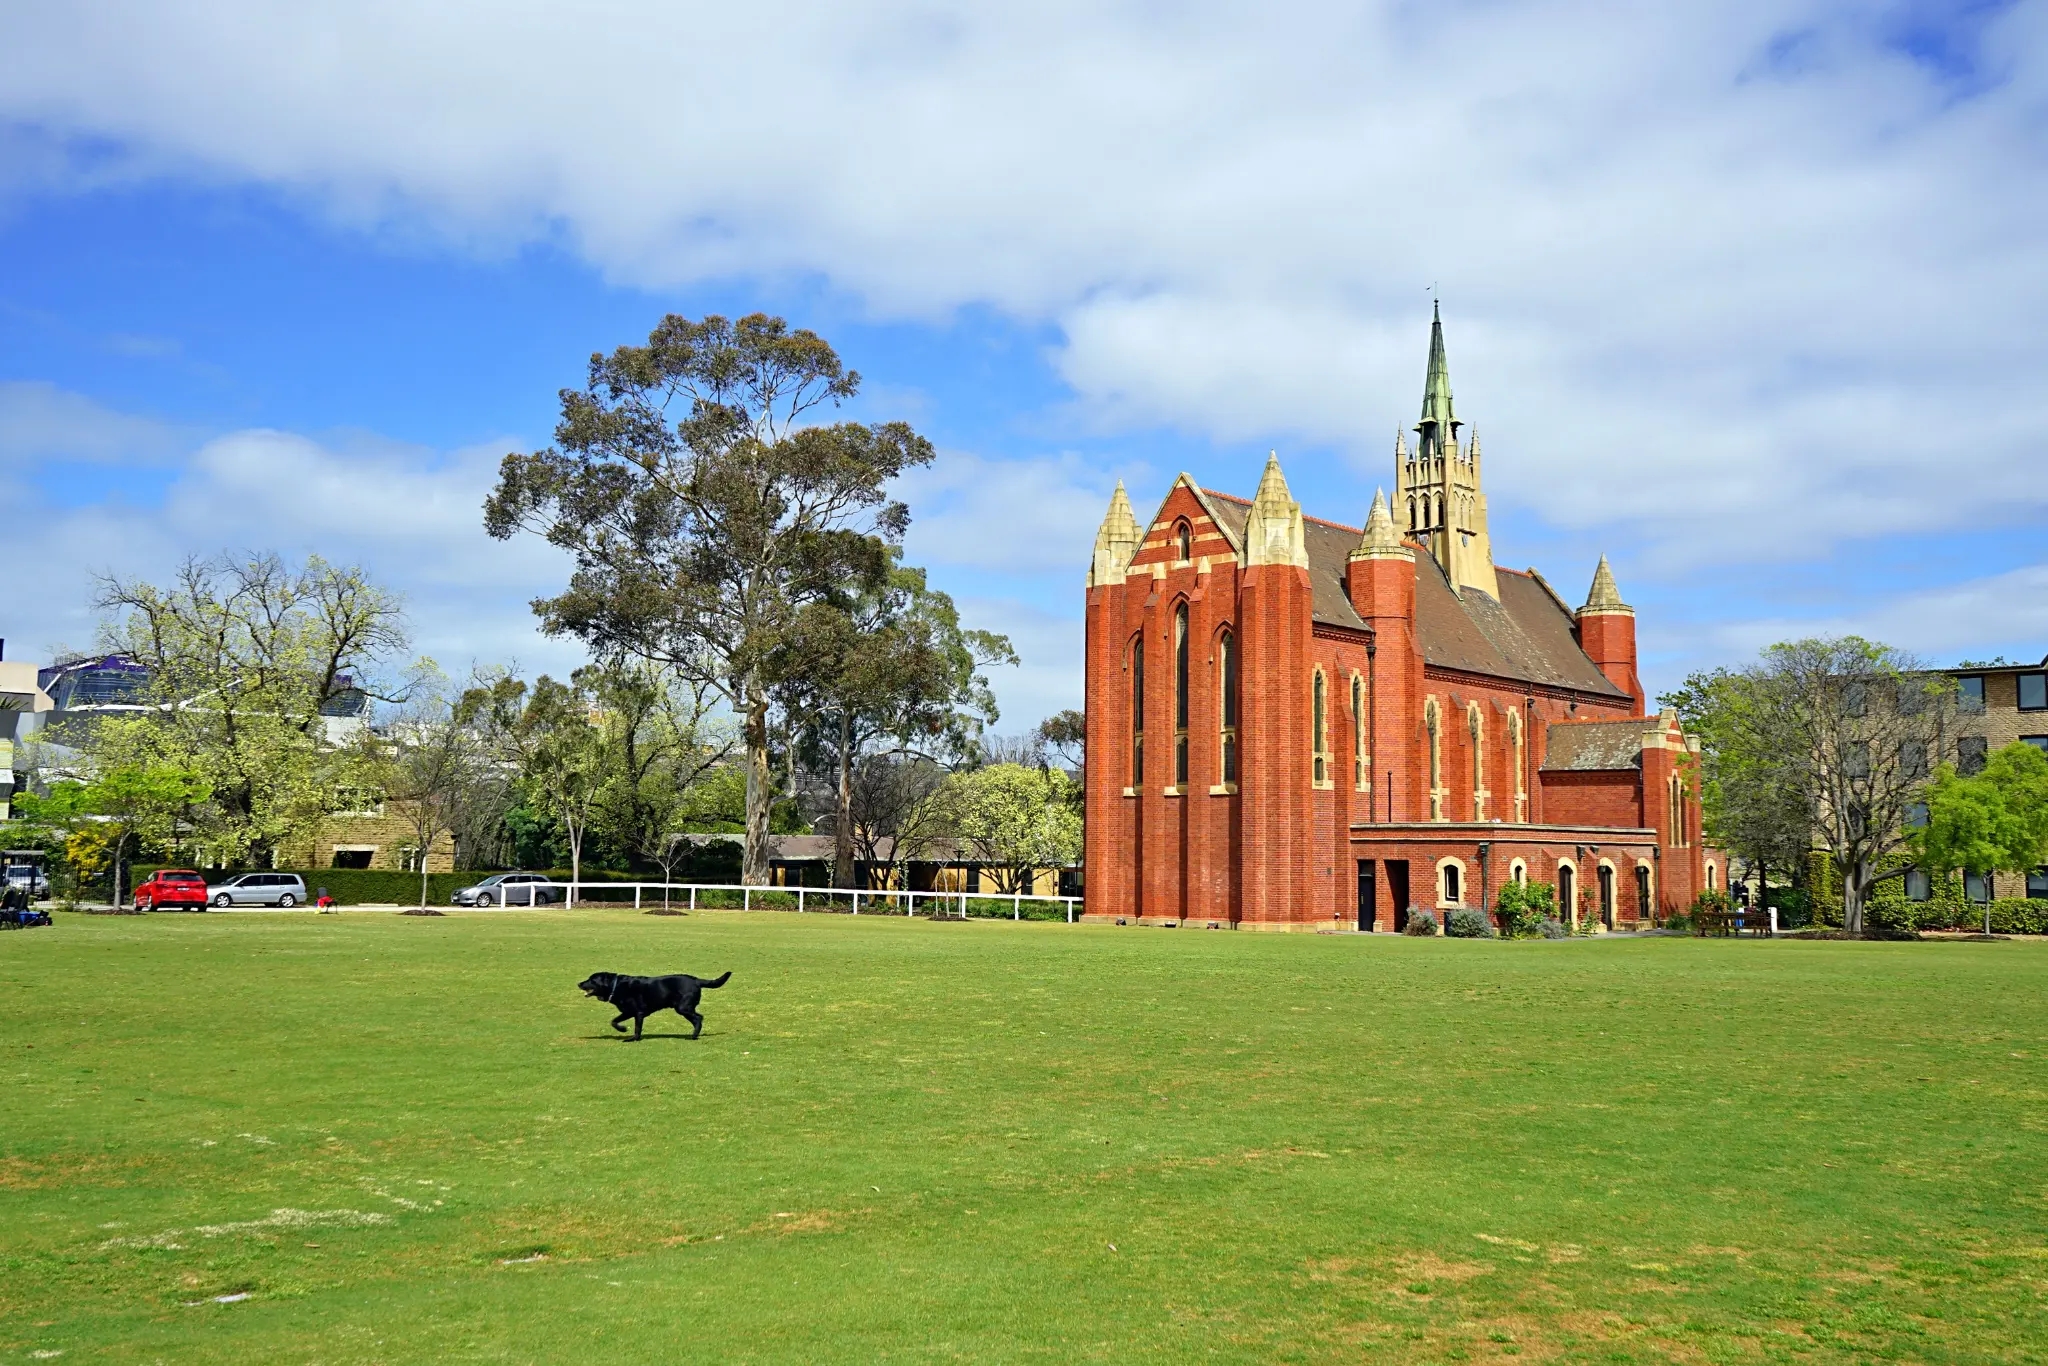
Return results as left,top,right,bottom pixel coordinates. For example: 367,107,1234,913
1909,739,2048,934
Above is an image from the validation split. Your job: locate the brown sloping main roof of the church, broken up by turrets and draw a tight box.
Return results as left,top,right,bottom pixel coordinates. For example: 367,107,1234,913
1202,489,1628,698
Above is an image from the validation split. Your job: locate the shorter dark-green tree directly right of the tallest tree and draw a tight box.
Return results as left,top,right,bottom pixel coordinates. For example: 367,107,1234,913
780,547,1018,887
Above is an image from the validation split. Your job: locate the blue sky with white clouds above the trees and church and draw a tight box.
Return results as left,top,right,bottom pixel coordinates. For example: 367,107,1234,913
0,0,2048,733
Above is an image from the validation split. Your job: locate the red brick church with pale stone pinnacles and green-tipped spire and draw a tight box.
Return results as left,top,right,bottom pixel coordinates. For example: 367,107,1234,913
1085,317,1724,930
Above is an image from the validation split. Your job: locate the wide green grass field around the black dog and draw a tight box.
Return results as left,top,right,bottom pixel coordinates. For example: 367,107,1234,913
0,911,2048,1364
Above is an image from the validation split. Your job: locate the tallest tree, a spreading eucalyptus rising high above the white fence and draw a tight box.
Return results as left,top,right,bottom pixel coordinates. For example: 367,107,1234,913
483,313,932,883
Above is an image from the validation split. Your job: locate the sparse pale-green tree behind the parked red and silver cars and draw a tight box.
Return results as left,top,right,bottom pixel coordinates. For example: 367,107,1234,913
91,555,406,860
